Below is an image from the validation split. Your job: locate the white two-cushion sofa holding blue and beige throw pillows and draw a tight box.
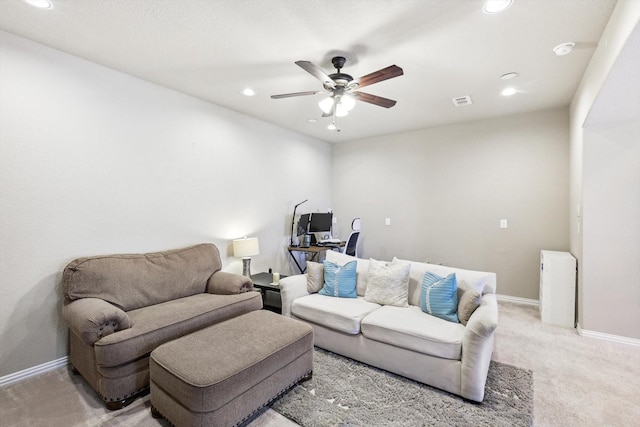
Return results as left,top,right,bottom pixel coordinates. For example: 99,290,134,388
280,251,498,402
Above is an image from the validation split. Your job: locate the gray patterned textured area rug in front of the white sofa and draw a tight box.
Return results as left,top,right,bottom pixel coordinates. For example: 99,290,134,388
271,348,533,427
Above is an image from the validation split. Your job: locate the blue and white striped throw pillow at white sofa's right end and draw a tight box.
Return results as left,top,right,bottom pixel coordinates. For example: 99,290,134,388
420,271,459,323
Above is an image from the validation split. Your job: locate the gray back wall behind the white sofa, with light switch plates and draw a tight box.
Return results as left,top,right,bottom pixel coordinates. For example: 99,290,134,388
332,108,569,300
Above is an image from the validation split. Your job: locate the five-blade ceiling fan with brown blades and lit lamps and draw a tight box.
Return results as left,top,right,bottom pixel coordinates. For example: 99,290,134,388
271,56,404,131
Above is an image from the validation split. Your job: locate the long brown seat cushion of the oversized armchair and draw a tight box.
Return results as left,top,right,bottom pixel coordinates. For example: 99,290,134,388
94,292,262,370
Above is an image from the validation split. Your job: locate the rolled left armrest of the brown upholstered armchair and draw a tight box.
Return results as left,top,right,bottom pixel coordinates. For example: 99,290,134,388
62,298,131,345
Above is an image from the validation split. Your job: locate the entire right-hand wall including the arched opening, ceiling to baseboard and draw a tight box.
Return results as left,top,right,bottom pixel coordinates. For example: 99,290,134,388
570,0,640,344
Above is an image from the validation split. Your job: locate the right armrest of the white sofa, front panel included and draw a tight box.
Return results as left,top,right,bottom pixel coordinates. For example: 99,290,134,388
460,294,498,402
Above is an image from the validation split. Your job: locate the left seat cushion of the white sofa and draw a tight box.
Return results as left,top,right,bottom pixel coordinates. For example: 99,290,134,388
291,294,380,335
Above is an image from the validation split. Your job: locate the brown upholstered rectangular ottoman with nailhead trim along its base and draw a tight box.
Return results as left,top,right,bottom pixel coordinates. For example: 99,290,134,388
149,310,313,427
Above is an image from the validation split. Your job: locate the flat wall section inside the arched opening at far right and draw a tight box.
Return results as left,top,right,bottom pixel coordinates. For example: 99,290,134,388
581,121,640,339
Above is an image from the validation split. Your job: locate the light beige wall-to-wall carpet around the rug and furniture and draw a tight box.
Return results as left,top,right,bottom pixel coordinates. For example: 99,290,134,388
0,302,640,427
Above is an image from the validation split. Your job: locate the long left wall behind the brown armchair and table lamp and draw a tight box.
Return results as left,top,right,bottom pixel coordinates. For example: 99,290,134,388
0,31,331,377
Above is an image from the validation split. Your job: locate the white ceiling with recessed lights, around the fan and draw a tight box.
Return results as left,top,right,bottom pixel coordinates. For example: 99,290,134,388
0,0,615,142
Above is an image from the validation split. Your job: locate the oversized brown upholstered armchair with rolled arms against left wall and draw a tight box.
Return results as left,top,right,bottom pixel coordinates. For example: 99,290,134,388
62,244,262,409
